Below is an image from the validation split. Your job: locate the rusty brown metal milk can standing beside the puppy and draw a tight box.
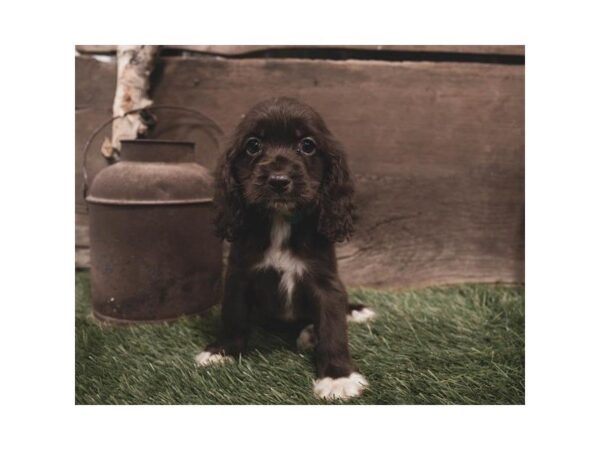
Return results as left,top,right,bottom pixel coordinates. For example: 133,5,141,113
86,139,222,323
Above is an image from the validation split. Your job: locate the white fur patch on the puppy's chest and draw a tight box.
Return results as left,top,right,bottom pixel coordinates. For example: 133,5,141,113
255,217,306,316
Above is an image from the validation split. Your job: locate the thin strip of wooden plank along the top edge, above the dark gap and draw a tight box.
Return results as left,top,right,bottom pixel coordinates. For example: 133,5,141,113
76,45,525,56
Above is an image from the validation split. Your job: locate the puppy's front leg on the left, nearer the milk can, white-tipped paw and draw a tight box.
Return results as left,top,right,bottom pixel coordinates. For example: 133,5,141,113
195,268,249,366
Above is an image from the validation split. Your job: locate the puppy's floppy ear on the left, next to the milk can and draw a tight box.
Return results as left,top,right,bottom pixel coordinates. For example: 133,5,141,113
214,143,245,241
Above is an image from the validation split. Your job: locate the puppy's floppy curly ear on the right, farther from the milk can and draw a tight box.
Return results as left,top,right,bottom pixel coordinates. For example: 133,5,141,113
318,138,356,242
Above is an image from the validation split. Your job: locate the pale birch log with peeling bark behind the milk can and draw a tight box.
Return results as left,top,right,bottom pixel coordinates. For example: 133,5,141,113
102,45,159,158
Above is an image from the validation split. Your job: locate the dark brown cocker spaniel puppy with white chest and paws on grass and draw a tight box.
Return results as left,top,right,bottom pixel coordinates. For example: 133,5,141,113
196,98,374,399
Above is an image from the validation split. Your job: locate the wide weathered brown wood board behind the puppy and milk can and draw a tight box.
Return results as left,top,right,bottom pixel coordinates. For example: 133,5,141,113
76,52,524,288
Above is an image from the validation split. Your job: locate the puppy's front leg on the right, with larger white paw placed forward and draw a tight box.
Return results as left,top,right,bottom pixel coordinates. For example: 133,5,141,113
314,280,369,399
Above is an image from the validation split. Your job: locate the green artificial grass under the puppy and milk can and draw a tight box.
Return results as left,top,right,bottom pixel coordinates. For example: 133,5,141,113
75,272,525,404
